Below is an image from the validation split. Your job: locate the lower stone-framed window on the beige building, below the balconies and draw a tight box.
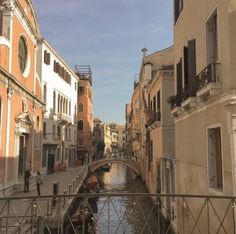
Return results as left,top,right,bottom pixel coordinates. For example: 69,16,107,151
207,127,223,189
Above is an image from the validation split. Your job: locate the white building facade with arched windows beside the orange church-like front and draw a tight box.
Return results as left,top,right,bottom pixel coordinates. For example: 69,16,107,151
37,39,79,174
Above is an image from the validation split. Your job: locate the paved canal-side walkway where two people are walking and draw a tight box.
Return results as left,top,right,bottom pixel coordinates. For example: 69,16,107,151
0,165,88,234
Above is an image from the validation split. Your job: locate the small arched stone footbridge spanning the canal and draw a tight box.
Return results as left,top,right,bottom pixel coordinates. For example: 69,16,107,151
88,157,141,175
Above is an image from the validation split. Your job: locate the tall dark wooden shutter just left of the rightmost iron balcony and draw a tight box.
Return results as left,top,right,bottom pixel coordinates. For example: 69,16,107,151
188,39,196,89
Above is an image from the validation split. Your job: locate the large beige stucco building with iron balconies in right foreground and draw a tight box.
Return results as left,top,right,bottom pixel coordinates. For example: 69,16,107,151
170,0,236,233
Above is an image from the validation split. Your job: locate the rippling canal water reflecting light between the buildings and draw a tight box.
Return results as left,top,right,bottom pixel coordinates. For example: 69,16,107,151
92,163,157,234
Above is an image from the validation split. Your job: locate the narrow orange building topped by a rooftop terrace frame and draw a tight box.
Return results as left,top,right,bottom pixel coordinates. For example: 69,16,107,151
75,65,94,163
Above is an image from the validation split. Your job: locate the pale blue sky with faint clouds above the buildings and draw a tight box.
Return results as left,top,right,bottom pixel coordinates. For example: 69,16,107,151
33,0,173,124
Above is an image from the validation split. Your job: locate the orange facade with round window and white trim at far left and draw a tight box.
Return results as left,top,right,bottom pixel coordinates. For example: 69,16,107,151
0,0,44,196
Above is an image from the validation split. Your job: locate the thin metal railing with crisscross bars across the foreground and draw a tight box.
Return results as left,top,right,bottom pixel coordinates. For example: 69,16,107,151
0,193,236,234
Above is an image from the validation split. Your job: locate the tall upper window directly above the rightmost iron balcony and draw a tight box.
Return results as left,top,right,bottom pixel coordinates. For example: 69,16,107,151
206,11,218,65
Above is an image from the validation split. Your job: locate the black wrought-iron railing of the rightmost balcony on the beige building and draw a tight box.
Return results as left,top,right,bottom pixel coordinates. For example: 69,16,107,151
196,63,219,91
